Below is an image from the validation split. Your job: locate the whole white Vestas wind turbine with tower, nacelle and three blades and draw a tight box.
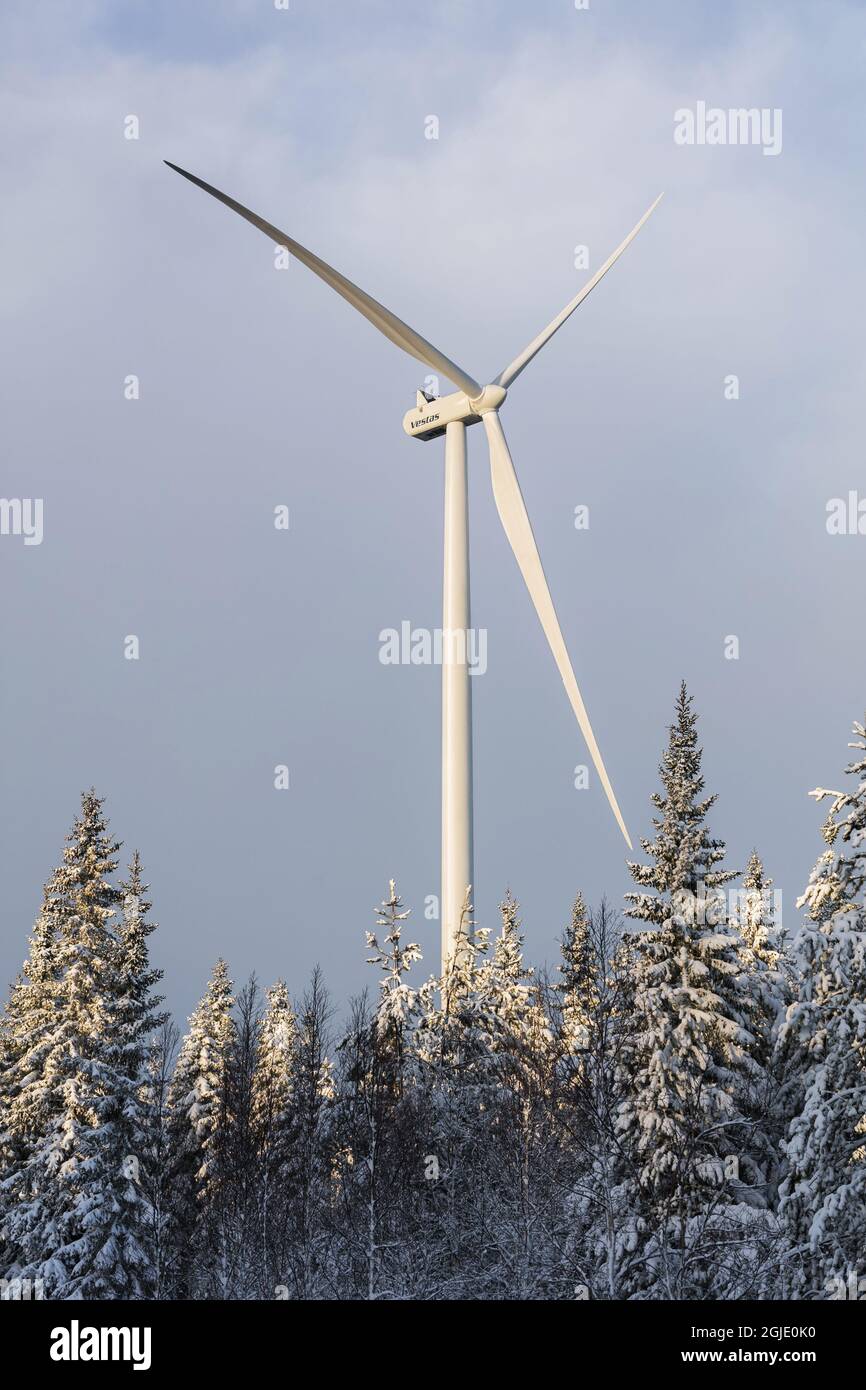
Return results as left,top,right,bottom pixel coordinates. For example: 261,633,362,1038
165,160,662,970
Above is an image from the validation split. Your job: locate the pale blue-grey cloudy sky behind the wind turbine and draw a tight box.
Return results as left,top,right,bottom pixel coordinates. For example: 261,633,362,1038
0,0,866,1020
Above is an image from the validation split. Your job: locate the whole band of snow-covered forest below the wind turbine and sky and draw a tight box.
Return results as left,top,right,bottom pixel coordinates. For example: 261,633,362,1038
0,687,866,1300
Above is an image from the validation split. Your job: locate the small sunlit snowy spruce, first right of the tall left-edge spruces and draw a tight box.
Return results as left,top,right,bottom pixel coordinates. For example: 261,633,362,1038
167,959,236,1298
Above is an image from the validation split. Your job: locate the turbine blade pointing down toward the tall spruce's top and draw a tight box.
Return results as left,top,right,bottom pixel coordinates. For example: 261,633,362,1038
481,410,632,849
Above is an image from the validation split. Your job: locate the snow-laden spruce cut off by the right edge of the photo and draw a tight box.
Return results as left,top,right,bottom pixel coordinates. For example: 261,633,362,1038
780,723,866,1297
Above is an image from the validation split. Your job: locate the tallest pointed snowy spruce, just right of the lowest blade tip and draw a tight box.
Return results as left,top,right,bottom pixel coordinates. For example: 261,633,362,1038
619,685,755,1297
